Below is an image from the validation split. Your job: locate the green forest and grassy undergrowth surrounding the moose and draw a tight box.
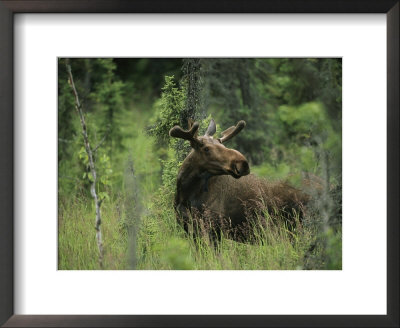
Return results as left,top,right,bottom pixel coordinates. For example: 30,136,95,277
58,58,342,270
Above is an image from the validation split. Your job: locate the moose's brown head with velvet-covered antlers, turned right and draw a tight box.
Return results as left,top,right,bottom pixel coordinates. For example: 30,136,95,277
169,120,250,179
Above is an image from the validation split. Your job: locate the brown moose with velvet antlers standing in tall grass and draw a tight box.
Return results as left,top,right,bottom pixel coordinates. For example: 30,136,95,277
169,119,309,242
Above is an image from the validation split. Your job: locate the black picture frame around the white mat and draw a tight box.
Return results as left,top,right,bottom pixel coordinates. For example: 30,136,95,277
0,0,400,327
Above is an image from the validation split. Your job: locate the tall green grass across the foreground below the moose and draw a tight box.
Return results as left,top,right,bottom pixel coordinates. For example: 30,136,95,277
59,188,341,270
